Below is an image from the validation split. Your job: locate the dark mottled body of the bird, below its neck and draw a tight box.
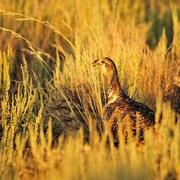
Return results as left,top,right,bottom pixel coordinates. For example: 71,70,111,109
103,94,154,143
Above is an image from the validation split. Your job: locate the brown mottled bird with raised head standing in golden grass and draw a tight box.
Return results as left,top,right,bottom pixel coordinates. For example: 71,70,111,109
92,57,155,146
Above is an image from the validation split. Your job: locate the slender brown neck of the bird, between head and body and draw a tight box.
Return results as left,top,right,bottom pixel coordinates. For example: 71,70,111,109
107,71,124,103
